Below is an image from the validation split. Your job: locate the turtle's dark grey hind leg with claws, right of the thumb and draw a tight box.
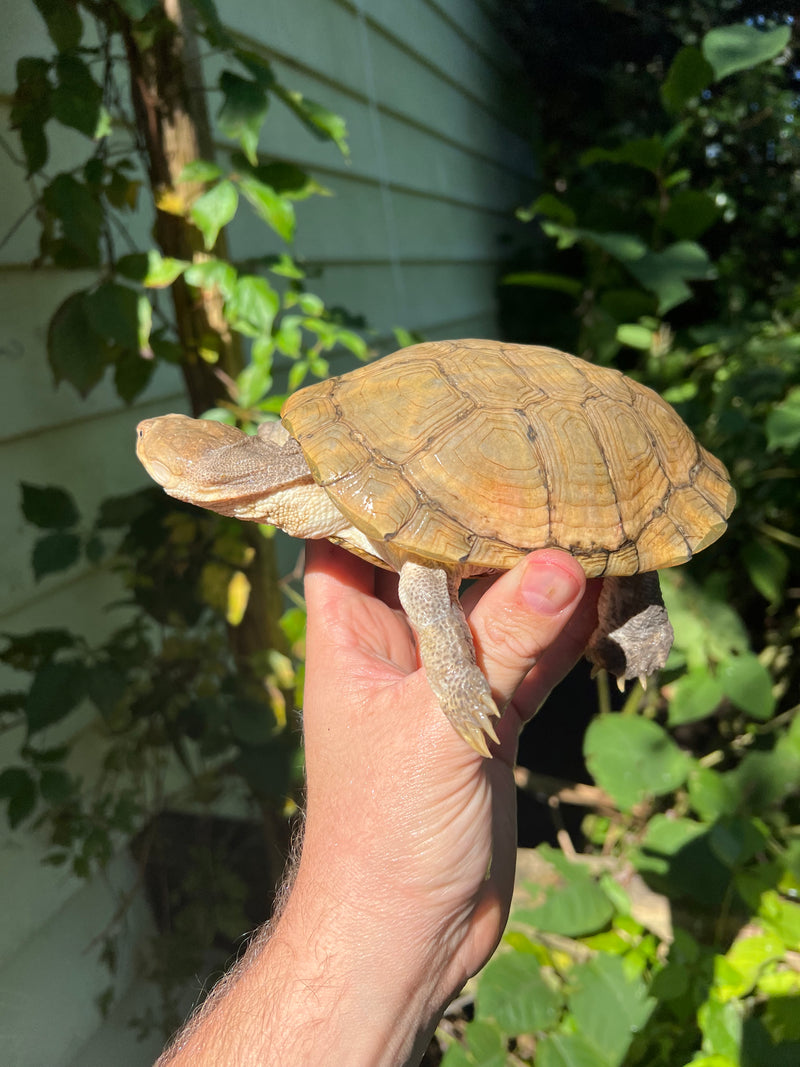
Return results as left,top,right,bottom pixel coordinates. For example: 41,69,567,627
586,571,674,688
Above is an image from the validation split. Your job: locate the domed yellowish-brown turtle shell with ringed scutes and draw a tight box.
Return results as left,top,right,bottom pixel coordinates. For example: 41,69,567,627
282,340,735,577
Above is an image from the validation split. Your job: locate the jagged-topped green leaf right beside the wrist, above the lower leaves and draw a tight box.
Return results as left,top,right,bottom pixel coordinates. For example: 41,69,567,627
514,846,614,937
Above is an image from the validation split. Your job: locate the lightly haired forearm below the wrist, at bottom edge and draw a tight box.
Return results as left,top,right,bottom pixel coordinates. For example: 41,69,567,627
159,849,459,1067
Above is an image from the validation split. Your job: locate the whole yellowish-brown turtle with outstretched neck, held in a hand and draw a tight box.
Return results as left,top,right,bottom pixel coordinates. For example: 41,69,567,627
137,339,735,755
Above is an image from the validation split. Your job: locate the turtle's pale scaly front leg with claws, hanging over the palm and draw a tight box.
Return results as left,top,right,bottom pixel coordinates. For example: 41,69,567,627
399,561,500,757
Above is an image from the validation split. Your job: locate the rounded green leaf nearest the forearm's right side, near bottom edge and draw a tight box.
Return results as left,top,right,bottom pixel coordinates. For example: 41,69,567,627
477,952,561,1035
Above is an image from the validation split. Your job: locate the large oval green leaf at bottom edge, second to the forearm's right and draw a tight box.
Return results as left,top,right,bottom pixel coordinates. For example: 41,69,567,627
570,954,655,1064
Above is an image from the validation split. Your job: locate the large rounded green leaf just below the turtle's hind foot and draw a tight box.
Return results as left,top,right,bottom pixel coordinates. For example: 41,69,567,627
583,715,690,811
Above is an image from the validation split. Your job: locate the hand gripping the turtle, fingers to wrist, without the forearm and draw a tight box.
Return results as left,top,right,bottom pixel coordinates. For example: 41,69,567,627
297,542,599,1062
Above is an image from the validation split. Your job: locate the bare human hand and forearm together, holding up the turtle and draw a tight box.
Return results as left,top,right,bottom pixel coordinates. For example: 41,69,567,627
163,541,599,1067
